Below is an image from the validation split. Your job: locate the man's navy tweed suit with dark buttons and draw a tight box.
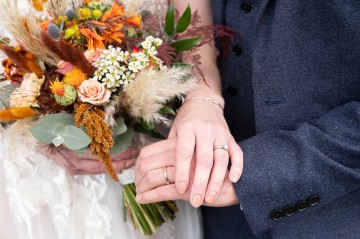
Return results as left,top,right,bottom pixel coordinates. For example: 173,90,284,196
204,0,360,238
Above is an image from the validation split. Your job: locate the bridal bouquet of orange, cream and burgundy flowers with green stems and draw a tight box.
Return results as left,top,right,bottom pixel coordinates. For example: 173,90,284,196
0,0,201,235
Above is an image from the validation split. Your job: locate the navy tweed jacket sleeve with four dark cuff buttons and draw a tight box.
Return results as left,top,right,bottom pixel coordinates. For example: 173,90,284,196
235,102,360,235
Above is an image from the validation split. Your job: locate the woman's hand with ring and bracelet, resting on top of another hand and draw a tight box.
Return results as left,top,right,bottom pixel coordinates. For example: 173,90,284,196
169,99,243,207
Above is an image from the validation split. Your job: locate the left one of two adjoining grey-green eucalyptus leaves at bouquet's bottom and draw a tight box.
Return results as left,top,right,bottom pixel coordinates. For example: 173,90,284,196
31,122,63,144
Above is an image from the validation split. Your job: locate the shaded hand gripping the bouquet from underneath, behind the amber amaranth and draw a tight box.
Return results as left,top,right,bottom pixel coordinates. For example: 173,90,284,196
38,144,139,175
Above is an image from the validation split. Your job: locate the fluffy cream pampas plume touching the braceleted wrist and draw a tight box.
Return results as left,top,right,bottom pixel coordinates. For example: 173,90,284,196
106,67,197,125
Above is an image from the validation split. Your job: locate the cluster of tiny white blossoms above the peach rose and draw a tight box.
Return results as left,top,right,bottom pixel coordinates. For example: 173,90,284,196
92,36,164,90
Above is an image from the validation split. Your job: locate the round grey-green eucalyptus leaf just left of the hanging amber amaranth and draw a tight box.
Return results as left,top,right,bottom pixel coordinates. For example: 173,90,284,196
62,125,91,150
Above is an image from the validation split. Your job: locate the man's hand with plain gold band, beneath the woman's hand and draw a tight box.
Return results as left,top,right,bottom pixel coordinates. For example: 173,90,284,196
135,138,239,207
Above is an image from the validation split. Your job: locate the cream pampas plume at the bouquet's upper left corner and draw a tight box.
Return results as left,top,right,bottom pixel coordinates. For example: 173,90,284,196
0,0,60,65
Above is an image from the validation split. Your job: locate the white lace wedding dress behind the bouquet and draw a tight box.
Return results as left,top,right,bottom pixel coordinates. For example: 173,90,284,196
0,0,202,239
